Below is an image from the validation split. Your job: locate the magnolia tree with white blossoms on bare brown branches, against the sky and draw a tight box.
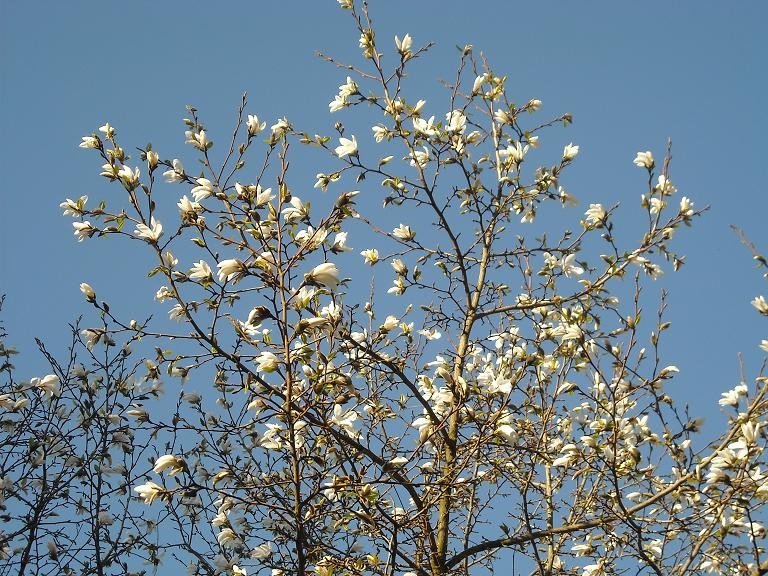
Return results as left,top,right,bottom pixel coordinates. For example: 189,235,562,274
0,0,768,576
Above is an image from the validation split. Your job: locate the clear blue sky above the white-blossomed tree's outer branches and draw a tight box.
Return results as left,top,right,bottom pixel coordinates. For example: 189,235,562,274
0,0,768,428
